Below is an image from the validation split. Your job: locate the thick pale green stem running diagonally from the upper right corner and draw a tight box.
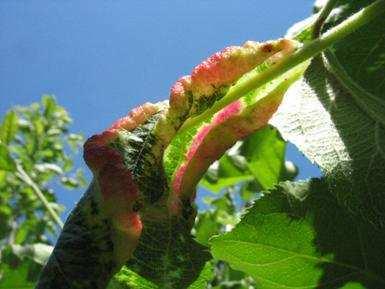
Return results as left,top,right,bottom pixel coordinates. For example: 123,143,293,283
180,0,385,130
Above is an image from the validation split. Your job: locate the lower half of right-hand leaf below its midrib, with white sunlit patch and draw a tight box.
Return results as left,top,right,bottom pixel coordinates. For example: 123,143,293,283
271,55,385,226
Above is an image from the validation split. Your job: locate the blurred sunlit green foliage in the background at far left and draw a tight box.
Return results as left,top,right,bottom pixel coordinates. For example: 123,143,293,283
0,95,85,288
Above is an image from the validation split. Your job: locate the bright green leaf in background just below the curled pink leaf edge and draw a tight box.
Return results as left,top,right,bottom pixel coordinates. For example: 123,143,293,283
200,126,286,193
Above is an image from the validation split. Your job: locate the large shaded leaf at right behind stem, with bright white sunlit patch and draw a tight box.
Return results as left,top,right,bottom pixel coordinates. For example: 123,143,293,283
271,0,385,227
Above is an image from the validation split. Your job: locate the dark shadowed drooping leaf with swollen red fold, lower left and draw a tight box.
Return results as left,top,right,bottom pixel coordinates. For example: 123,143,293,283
37,105,211,289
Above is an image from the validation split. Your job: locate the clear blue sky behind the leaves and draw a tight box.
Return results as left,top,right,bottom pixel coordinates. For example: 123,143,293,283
0,0,319,216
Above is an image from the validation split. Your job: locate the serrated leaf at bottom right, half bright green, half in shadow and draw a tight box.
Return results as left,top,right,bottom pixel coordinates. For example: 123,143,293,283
211,180,385,289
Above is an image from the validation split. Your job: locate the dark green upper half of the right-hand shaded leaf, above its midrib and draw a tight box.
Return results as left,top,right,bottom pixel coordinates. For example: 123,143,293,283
324,0,385,127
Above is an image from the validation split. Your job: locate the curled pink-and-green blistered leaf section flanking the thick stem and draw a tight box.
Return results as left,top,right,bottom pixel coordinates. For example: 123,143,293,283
163,40,307,200
